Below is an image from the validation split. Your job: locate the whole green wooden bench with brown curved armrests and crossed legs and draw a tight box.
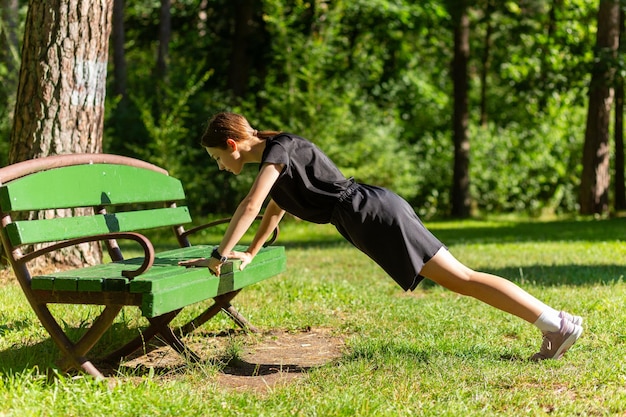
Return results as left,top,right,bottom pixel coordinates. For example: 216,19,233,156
0,154,286,378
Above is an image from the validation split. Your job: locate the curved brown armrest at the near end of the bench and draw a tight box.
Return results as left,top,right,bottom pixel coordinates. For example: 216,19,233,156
19,232,154,279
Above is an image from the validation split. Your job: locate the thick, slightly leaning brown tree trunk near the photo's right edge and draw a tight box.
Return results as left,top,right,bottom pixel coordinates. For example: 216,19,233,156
578,0,619,214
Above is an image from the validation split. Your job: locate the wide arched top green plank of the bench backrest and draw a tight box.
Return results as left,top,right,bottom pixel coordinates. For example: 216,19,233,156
0,164,185,212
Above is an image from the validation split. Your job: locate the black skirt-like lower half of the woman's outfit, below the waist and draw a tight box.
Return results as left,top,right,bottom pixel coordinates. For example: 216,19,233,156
331,183,444,291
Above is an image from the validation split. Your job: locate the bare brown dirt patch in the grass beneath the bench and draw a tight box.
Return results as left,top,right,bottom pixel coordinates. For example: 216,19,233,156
117,328,345,393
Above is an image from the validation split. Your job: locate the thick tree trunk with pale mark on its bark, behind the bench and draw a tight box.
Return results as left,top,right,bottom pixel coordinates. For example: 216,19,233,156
9,0,113,265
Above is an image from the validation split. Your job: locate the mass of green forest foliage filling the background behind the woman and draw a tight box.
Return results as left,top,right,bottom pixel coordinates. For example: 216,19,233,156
0,0,597,217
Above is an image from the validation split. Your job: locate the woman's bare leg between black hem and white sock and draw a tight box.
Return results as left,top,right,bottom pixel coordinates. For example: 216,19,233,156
421,248,549,323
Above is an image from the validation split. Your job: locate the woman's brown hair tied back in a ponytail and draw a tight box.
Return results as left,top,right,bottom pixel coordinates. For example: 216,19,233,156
200,112,280,149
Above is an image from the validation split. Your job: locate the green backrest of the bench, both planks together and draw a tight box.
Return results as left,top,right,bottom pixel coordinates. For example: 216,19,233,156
0,158,191,247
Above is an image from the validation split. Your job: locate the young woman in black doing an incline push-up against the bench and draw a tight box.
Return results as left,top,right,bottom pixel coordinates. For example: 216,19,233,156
185,113,583,360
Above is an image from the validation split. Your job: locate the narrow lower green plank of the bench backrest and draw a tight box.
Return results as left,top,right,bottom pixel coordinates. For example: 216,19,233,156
6,207,191,246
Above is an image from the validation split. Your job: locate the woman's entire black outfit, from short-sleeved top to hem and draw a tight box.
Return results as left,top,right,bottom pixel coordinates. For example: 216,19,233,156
261,133,444,291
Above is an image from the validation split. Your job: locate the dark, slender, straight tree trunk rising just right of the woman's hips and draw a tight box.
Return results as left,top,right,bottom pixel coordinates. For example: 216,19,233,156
451,0,471,218
